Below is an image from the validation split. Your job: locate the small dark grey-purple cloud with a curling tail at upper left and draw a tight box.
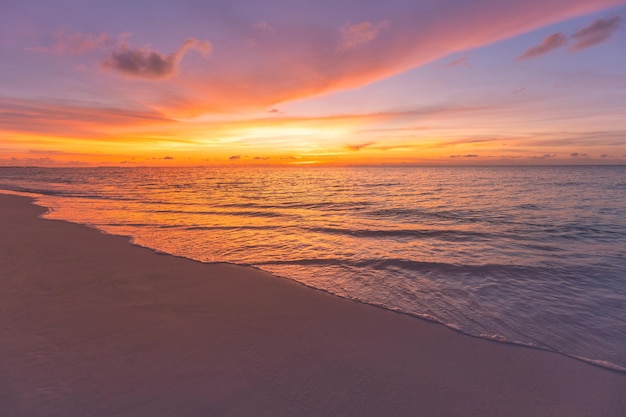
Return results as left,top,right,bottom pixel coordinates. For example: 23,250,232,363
102,38,212,79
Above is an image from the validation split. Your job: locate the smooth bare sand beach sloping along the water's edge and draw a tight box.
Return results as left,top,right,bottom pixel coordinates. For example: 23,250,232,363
0,195,626,417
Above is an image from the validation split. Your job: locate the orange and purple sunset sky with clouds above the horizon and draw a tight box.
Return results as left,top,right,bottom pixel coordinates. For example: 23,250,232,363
0,0,626,166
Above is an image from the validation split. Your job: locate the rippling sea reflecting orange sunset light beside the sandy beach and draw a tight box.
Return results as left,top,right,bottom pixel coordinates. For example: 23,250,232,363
0,167,626,370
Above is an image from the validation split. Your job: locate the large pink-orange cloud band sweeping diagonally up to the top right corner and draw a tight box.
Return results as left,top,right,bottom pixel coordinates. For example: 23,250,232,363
161,0,624,117
